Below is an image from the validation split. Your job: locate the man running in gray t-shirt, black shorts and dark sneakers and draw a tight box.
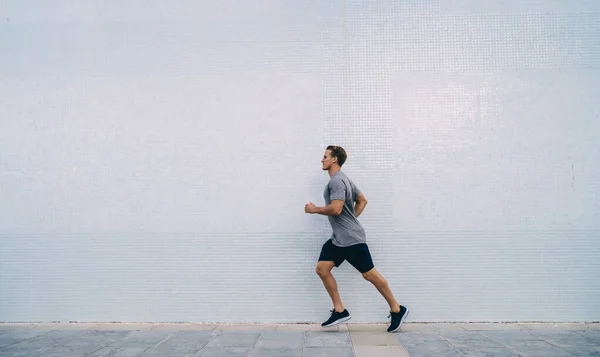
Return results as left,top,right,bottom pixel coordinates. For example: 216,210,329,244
304,145,408,332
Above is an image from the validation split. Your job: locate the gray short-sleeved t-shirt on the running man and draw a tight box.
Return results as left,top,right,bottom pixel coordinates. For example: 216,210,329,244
323,171,367,247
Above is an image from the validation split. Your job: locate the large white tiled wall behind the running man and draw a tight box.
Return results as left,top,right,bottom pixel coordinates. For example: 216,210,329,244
0,0,600,322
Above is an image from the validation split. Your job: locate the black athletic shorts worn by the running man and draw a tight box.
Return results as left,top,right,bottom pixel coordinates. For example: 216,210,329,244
319,239,375,273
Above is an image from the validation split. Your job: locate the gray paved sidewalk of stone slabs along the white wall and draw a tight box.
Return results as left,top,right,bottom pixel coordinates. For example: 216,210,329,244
0,323,600,357
